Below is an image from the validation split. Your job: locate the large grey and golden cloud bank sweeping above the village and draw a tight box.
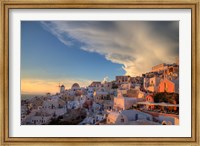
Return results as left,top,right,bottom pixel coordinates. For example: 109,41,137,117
42,21,179,76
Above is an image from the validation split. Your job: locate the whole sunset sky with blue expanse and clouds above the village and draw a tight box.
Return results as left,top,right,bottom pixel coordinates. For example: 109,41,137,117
21,21,179,94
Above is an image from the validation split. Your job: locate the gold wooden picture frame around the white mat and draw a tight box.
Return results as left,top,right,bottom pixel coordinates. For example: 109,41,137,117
0,0,200,145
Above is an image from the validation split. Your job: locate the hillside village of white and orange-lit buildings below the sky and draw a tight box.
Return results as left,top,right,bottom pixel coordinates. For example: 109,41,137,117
21,62,179,125
